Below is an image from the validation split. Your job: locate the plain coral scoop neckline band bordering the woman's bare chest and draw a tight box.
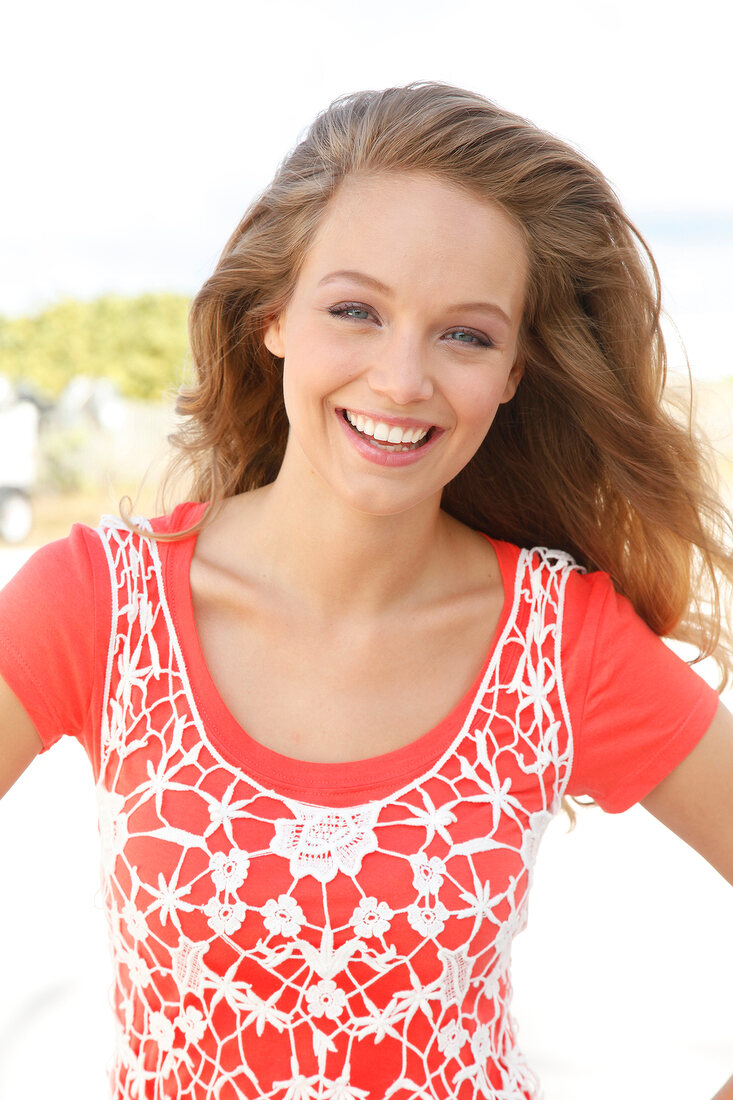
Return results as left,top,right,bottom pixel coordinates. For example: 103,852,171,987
161,502,517,804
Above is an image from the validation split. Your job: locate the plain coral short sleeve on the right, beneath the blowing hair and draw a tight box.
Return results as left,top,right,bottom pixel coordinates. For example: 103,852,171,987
562,572,719,813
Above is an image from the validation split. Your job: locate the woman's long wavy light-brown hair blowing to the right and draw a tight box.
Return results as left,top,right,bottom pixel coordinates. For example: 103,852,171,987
120,81,733,818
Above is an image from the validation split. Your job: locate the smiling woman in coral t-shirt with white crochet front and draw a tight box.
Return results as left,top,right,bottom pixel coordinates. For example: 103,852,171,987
0,84,733,1100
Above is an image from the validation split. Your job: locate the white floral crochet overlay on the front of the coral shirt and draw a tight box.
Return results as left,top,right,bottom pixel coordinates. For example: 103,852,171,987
98,517,578,1100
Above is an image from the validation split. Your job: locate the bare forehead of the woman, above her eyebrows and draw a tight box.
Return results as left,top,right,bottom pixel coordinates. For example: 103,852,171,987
300,173,527,314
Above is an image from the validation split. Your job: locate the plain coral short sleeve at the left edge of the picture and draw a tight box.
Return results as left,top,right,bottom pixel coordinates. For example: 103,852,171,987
0,524,111,755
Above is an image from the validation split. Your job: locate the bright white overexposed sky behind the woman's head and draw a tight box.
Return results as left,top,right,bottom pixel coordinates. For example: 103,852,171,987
0,0,733,373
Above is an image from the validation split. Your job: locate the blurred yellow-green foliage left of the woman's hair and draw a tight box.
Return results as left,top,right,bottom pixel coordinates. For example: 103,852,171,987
0,294,190,400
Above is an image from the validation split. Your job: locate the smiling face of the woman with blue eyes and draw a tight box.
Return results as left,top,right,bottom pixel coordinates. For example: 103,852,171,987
265,174,527,515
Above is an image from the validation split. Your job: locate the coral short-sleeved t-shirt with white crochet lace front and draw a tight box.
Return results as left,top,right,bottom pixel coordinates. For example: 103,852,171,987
0,503,718,1100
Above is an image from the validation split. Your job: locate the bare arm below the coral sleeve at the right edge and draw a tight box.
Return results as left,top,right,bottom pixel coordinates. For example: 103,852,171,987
642,703,733,888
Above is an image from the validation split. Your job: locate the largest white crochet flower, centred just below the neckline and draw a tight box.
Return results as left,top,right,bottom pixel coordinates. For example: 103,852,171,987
270,802,379,882
